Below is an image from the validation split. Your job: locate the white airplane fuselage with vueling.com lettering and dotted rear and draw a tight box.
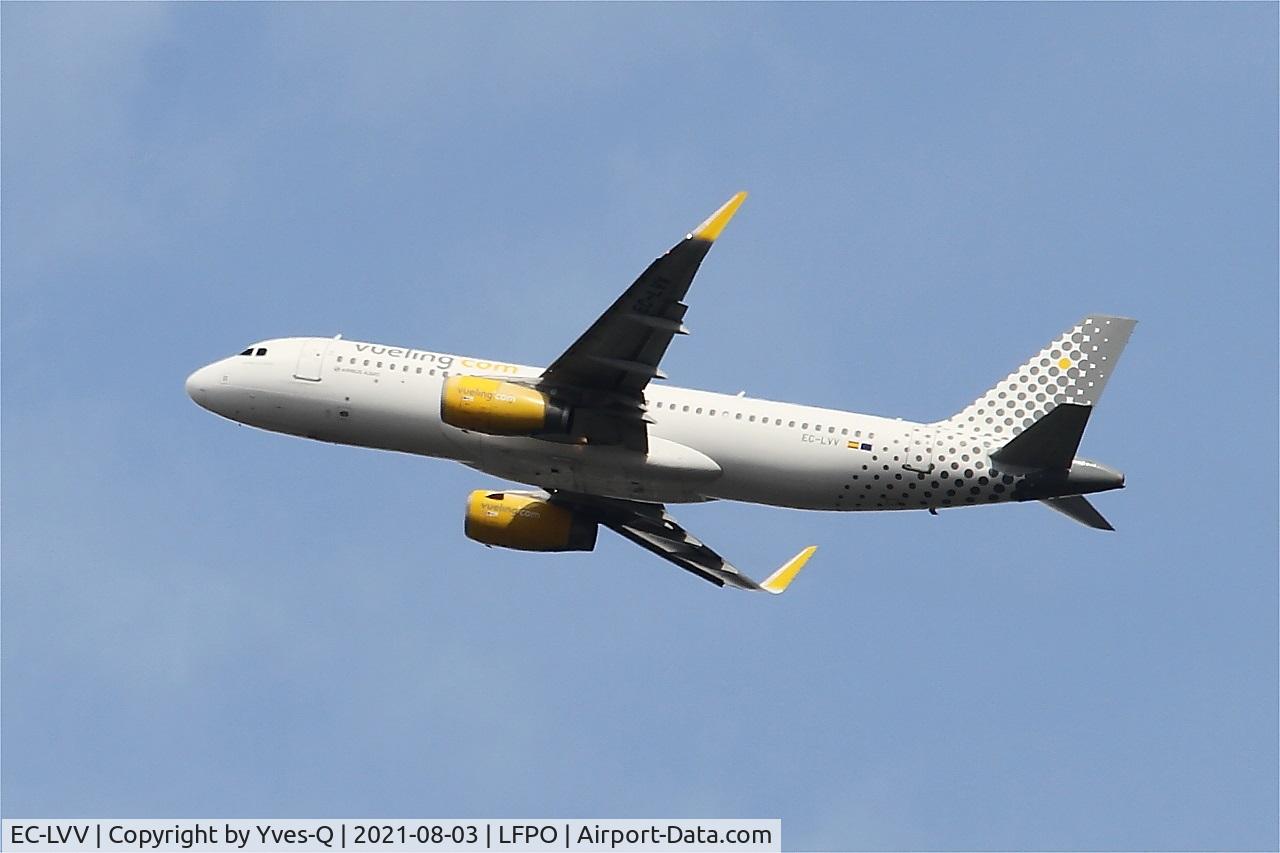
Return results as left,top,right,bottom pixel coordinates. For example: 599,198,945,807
187,338,1020,511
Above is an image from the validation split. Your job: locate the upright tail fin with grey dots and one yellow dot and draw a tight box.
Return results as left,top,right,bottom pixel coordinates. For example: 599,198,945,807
945,314,1138,439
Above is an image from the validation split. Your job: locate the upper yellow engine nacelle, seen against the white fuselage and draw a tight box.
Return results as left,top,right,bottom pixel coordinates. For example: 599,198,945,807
440,377,568,435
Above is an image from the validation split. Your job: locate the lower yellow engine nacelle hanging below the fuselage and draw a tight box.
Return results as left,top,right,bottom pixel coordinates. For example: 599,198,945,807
466,489,599,551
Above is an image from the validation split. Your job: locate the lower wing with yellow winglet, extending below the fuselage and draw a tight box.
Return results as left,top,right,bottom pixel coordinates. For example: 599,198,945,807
552,492,818,596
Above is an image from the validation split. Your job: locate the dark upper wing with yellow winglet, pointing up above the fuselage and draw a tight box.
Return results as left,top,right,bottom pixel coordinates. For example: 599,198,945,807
538,192,746,452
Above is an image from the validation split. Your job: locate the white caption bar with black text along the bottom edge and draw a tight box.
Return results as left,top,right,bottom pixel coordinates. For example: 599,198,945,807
0,818,782,853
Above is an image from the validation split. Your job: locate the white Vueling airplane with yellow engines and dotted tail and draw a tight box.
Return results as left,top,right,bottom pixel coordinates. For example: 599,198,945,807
186,192,1135,594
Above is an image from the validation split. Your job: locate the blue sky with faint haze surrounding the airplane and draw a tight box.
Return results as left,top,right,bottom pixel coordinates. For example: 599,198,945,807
0,3,1280,849
